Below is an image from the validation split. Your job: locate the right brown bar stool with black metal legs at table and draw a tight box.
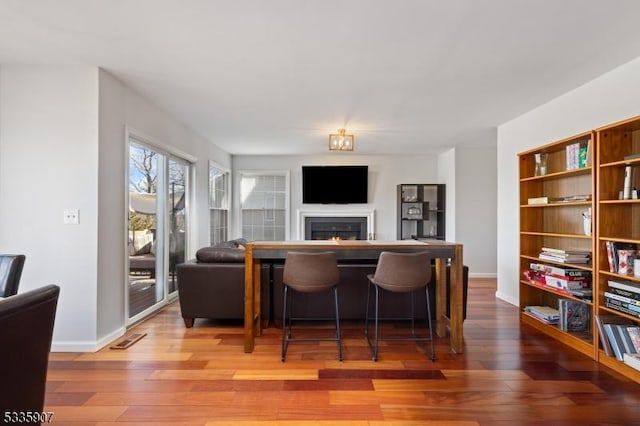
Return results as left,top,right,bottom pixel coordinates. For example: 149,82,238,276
364,252,436,361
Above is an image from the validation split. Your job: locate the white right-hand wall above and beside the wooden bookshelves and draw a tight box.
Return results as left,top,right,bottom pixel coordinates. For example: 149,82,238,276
497,58,640,304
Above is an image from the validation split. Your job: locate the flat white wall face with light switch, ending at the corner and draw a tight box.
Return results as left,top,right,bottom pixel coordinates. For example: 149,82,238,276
0,65,98,343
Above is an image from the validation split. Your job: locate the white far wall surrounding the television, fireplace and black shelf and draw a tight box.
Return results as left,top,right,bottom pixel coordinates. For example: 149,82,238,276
232,151,497,276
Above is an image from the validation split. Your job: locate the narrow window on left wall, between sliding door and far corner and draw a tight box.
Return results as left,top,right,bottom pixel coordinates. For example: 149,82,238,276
209,162,231,245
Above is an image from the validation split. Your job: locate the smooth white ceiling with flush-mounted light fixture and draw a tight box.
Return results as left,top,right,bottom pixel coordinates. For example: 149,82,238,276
0,0,640,154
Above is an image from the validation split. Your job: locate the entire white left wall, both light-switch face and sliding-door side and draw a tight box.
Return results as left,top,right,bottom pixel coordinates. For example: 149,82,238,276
0,65,231,351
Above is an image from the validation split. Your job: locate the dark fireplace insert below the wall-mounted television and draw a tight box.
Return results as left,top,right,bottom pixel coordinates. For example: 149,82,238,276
304,216,367,240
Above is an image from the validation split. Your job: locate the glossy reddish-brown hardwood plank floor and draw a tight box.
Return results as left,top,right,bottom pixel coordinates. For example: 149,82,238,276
46,279,640,426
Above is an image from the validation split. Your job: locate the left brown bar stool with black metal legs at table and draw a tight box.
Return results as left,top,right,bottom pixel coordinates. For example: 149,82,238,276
282,252,342,362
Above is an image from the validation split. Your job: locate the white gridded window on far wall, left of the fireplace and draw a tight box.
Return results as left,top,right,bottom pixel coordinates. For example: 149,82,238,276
240,172,289,241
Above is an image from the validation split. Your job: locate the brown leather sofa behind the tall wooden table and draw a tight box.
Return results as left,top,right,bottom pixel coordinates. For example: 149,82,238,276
177,243,469,327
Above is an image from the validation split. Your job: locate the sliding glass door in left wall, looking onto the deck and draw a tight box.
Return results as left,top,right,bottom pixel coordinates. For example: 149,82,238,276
127,137,189,321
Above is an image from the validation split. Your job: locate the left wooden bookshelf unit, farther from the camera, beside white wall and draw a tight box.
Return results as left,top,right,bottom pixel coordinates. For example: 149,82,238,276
518,132,598,359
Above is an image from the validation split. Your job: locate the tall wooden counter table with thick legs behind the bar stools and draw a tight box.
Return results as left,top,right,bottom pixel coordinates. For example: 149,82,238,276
244,240,464,353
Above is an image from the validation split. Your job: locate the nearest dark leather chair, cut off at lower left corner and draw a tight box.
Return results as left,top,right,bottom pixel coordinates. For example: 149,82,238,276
0,285,60,424
